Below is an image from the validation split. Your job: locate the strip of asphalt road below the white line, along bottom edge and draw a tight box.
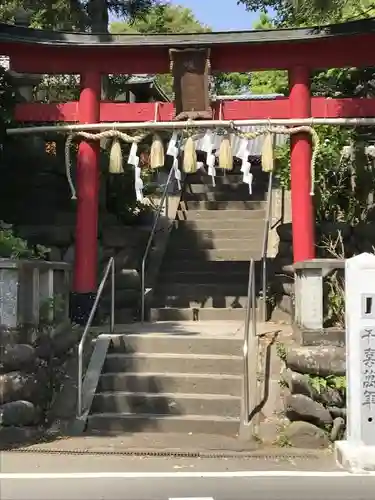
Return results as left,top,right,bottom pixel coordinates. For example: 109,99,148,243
0,474,375,500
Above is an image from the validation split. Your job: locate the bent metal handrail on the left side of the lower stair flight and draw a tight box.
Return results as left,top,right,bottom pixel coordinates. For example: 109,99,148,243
77,257,115,418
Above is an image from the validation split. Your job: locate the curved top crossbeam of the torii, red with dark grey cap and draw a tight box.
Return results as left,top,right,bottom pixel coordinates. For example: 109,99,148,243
0,19,375,74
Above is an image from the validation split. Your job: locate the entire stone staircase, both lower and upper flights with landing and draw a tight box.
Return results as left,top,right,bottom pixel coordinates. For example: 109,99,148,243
86,167,267,436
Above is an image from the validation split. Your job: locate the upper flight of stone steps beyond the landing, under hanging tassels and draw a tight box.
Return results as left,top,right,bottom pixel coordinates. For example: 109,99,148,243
151,169,267,321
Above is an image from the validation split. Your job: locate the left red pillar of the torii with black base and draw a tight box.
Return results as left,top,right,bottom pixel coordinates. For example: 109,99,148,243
71,71,101,324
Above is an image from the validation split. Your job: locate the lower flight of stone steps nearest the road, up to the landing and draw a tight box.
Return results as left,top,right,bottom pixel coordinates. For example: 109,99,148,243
86,322,243,436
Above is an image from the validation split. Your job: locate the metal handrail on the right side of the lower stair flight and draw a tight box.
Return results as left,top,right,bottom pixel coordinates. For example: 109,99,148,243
243,259,257,425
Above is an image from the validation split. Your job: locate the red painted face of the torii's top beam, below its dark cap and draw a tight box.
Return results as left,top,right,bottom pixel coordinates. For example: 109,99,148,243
4,33,375,74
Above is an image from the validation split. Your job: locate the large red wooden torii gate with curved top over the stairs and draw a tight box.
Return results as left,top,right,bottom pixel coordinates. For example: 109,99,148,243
0,19,375,312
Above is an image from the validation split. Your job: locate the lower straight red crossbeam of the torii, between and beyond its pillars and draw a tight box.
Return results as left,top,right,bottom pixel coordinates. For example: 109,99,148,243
15,97,375,123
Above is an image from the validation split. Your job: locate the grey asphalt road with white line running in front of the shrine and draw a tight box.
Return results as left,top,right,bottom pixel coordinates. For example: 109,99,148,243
0,453,375,500
